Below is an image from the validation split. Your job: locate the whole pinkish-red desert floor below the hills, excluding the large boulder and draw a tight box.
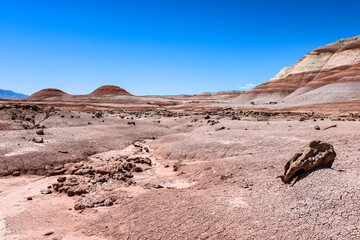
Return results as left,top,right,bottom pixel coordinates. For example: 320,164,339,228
0,94,360,240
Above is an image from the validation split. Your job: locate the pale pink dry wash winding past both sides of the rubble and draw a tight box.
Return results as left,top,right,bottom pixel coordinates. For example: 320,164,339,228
0,140,196,240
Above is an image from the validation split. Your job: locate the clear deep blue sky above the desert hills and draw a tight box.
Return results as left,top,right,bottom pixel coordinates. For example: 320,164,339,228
0,0,360,95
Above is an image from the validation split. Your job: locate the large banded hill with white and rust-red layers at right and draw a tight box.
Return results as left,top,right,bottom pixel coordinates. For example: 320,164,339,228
235,36,360,106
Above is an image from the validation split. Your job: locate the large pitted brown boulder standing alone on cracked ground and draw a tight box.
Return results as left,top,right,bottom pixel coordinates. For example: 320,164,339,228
279,141,336,183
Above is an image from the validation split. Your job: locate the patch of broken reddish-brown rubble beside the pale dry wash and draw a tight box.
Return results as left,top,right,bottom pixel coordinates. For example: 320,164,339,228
50,141,152,210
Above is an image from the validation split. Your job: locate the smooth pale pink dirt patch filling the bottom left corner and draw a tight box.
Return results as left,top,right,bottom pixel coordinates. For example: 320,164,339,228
0,176,112,240
